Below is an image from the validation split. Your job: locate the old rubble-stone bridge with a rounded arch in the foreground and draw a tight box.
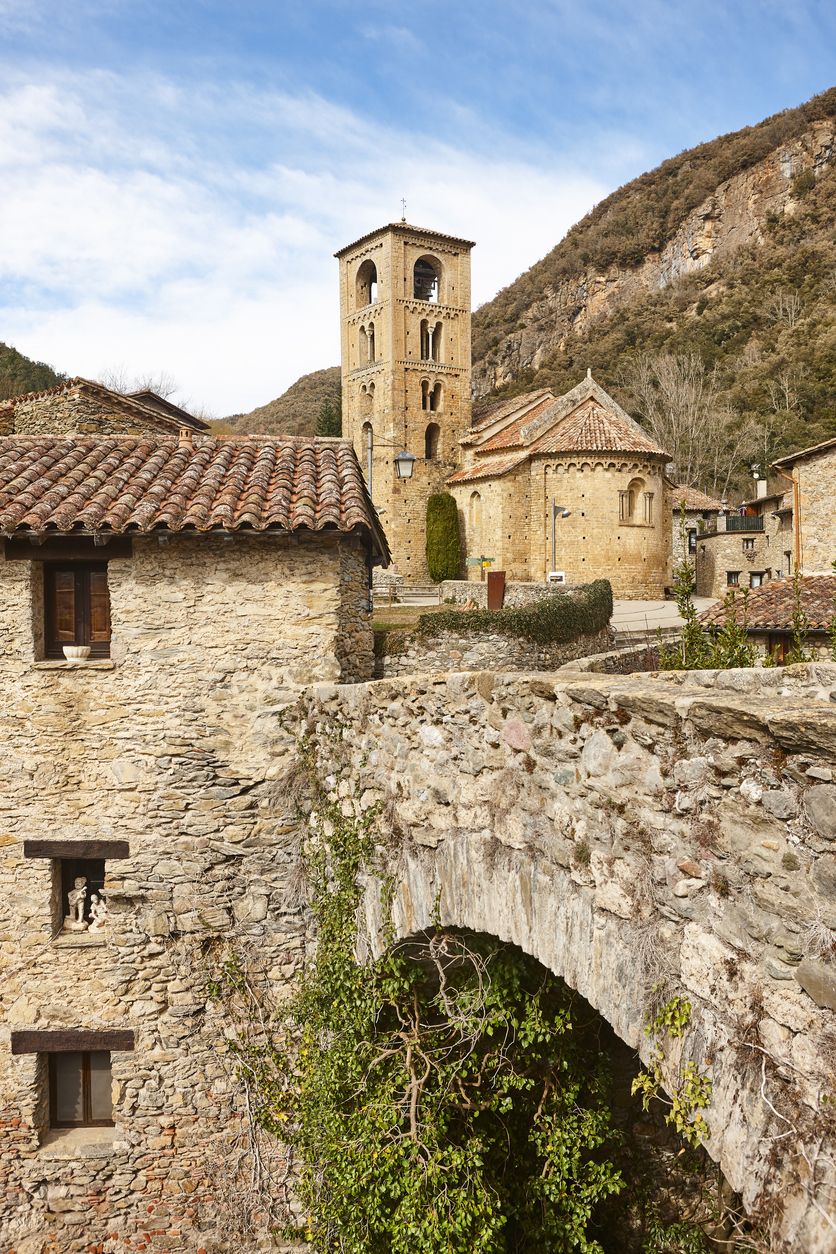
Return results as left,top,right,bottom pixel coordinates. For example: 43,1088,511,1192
295,665,836,1254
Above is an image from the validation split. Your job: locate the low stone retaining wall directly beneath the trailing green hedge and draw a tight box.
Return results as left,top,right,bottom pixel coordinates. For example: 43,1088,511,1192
375,628,613,678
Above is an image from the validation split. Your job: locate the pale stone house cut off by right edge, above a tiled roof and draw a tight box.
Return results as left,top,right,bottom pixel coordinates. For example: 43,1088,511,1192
773,428,836,574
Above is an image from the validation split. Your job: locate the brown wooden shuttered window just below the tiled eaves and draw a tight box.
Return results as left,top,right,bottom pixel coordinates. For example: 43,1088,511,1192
44,562,110,657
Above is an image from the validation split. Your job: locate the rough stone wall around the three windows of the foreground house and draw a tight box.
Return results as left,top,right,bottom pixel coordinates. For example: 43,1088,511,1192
0,535,371,1254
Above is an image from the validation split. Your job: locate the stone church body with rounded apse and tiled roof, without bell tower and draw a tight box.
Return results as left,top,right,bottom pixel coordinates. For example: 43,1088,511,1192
447,372,671,598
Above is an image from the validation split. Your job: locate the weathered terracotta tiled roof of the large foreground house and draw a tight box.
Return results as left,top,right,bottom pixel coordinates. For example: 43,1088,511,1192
0,435,390,562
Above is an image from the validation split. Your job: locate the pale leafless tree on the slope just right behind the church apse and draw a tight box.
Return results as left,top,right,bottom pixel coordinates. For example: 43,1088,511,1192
622,352,758,495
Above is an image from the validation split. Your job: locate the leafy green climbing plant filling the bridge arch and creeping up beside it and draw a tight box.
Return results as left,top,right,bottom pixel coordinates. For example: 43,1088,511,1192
212,745,623,1254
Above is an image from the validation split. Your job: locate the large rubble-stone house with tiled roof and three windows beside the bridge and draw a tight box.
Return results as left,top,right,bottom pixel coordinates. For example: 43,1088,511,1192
0,434,389,1254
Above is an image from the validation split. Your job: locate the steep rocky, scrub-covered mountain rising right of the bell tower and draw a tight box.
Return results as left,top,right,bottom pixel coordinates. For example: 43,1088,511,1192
473,89,836,466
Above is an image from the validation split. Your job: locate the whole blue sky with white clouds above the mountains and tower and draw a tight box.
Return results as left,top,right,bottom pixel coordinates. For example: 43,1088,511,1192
0,0,836,416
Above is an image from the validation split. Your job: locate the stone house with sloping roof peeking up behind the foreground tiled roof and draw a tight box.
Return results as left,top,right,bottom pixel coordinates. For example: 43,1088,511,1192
0,379,208,436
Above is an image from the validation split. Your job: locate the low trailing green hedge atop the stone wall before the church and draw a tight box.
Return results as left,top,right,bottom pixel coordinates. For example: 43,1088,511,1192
415,579,613,645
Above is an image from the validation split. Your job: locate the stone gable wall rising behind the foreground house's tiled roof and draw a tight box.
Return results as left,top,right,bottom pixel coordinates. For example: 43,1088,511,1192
0,385,184,436
